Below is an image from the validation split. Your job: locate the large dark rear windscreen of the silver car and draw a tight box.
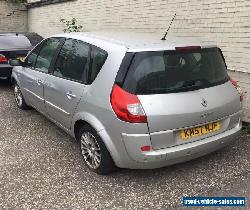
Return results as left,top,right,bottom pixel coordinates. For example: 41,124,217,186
122,48,228,95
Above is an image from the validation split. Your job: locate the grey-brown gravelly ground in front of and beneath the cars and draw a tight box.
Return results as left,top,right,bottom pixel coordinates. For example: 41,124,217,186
0,80,250,210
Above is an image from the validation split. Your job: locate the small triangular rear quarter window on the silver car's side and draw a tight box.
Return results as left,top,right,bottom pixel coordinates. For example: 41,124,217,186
89,46,108,83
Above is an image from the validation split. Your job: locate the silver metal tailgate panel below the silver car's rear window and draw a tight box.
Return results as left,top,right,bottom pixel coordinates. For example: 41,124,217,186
139,82,241,147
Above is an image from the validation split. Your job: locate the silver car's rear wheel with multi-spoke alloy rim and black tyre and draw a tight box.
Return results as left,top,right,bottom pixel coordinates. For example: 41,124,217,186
79,125,116,174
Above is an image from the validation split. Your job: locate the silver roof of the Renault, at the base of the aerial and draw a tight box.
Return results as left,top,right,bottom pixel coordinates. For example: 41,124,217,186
54,31,216,52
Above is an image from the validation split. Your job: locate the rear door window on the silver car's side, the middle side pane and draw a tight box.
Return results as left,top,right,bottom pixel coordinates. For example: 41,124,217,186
54,39,90,82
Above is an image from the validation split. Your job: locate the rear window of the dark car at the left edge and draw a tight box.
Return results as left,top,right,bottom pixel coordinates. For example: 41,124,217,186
0,33,32,50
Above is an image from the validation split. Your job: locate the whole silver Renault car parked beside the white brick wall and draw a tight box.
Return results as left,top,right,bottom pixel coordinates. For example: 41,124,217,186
10,32,242,174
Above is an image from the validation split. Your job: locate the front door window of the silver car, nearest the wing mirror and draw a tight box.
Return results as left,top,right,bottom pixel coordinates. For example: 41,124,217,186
35,38,60,73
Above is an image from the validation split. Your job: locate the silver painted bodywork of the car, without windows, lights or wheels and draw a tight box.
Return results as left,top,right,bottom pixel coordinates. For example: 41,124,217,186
12,32,241,169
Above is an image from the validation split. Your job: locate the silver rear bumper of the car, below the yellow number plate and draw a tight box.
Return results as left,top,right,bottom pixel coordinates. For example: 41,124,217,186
122,122,242,169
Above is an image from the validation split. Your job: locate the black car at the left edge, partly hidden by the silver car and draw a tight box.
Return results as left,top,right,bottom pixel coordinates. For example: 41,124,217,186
0,32,43,78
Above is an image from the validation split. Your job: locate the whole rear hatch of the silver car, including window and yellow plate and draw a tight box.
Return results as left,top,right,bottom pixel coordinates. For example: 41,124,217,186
120,47,241,149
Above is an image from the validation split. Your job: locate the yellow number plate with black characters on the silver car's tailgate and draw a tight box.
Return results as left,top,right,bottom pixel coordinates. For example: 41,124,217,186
180,122,221,140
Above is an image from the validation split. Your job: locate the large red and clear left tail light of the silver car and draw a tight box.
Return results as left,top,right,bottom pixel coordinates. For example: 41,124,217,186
110,84,147,123
